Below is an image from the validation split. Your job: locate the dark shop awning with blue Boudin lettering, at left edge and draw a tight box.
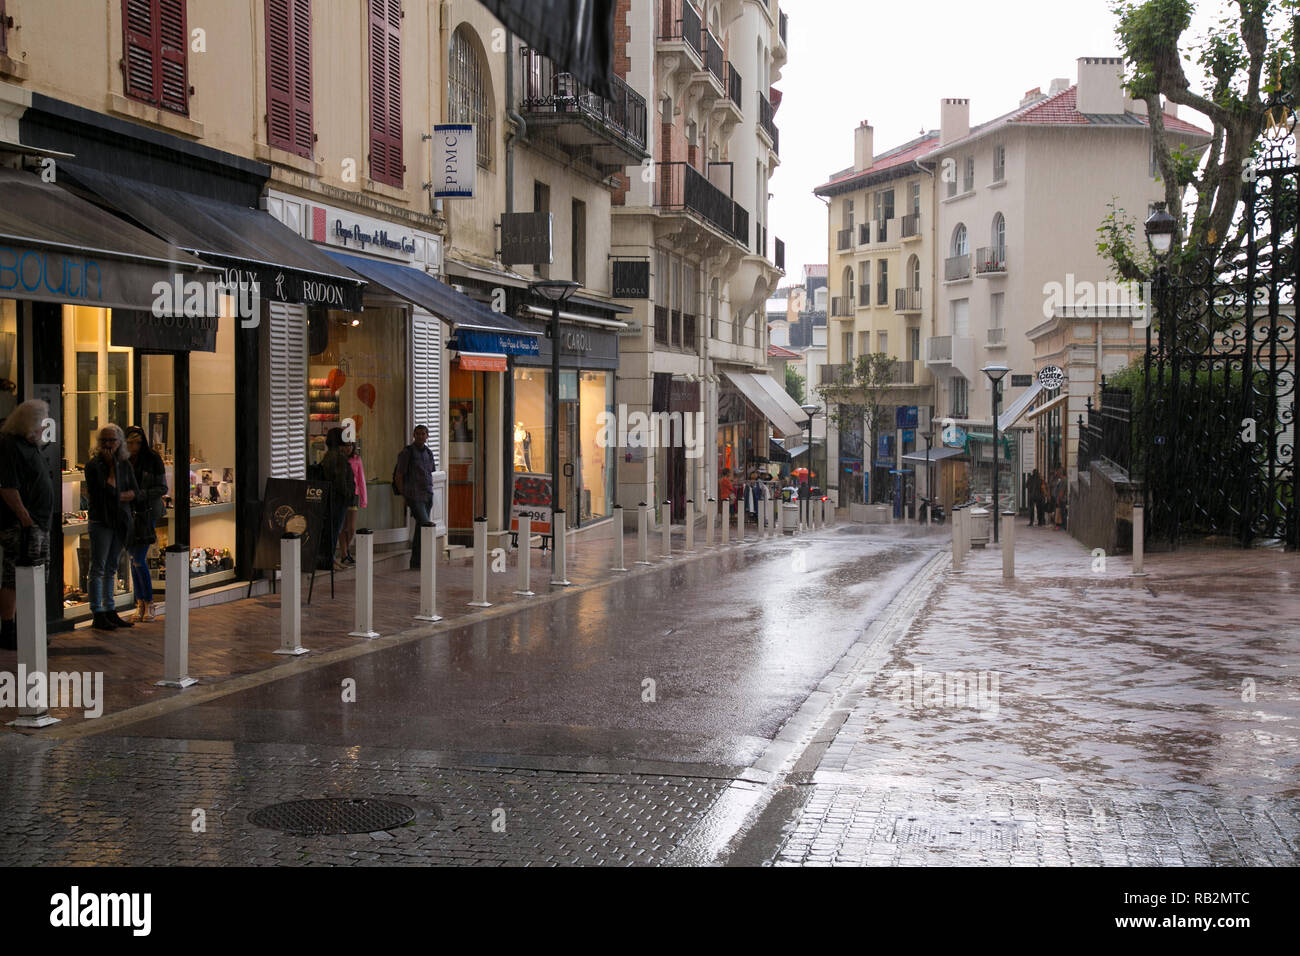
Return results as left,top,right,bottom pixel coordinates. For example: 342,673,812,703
0,166,216,312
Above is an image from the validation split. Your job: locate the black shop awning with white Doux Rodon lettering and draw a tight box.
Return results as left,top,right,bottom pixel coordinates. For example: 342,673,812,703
59,163,365,312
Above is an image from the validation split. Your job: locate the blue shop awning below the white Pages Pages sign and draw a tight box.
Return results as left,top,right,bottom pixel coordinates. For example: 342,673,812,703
326,251,538,355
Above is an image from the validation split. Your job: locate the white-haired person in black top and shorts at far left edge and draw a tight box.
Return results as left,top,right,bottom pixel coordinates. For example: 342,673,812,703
0,398,55,650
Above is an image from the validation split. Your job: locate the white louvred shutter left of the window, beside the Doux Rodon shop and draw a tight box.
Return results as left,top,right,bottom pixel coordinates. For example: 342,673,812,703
268,302,307,479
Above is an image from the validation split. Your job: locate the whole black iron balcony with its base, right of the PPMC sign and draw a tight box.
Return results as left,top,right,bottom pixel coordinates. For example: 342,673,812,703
517,47,647,176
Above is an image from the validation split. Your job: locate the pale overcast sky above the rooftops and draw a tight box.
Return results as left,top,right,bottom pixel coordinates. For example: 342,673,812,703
770,0,1237,285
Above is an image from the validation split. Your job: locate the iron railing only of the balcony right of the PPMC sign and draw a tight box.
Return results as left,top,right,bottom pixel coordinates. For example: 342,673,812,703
519,47,646,155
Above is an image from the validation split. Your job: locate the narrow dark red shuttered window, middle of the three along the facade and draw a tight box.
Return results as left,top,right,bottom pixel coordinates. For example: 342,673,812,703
267,0,315,159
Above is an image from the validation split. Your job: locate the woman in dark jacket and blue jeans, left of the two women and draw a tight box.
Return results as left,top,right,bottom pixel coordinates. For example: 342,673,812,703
86,425,139,631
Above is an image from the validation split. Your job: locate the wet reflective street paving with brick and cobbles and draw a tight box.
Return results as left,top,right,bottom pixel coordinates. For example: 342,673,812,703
0,524,1300,865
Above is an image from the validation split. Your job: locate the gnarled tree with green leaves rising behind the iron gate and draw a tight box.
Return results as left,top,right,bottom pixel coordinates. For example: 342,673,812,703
1097,0,1300,281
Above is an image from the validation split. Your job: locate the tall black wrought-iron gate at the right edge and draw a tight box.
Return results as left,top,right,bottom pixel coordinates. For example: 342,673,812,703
1134,100,1300,548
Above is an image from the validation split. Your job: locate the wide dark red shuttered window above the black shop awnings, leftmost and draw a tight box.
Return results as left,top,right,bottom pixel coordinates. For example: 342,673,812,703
122,0,190,116
